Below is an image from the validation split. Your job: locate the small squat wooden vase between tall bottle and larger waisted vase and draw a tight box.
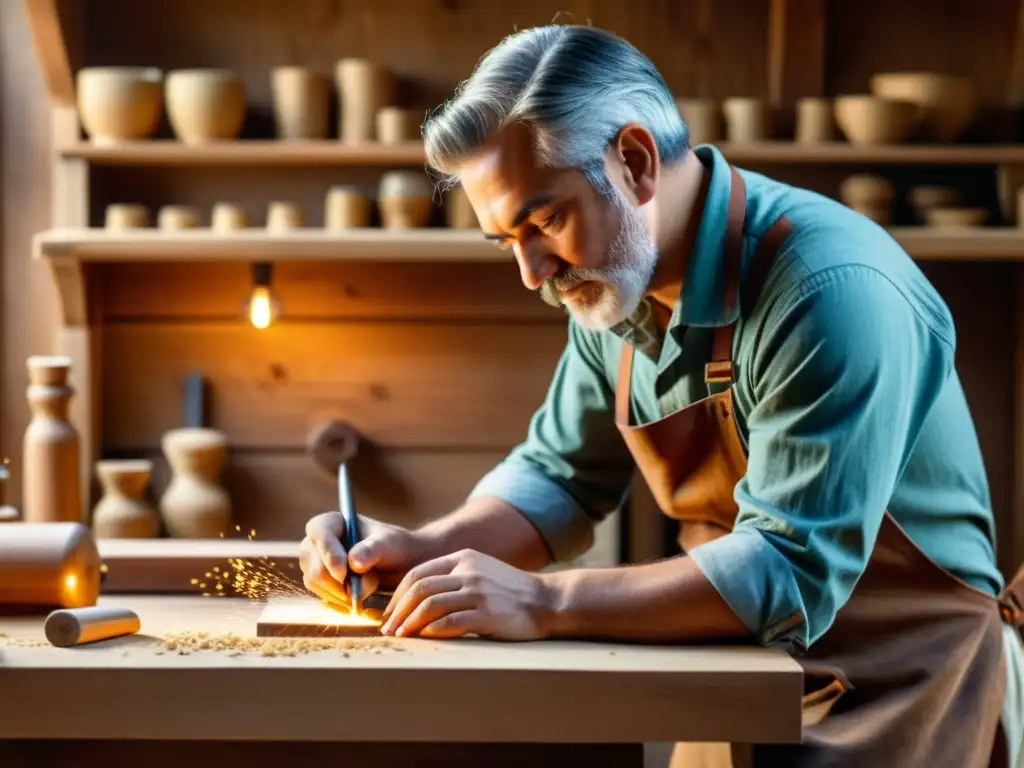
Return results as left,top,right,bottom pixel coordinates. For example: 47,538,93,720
92,459,160,539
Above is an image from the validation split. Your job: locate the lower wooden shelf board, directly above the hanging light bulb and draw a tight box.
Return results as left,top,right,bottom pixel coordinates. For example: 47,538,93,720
35,227,1024,262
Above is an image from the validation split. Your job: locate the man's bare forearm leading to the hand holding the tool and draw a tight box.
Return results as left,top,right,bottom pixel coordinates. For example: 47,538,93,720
417,497,551,570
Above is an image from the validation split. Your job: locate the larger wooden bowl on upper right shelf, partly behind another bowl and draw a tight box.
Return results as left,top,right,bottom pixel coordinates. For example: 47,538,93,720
870,72,978,142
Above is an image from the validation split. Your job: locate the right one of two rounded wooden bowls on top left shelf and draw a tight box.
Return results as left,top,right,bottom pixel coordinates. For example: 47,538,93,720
167,69,246,144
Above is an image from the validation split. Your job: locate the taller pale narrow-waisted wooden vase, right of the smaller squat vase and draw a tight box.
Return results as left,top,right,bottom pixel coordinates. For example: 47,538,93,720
160,427,231,539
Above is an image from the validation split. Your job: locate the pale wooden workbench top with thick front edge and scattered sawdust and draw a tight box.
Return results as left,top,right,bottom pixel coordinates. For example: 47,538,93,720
0,595,803,743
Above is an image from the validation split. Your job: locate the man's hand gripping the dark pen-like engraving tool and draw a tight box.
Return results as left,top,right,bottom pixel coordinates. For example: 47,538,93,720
299,512,428,605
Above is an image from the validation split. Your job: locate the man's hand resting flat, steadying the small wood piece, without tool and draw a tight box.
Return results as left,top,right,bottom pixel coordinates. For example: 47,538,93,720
381,550,554,640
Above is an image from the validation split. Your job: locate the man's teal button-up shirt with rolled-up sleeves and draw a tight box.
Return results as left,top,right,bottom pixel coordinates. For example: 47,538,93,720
470,145,1002,648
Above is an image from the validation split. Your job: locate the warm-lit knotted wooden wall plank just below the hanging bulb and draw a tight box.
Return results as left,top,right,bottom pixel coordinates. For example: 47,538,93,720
103,323,566,450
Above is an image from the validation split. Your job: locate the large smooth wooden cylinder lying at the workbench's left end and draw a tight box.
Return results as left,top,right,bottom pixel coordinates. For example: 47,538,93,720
0,522,100,608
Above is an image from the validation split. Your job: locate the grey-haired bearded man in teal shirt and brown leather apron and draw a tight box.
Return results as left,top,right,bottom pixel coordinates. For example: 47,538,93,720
302,26,1021,768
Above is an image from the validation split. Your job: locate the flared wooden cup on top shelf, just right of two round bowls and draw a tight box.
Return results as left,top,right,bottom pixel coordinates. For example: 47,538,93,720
270,67,331,140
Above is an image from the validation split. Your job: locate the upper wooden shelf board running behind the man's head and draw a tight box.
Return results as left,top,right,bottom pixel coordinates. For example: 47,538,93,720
58,140,1024,166
